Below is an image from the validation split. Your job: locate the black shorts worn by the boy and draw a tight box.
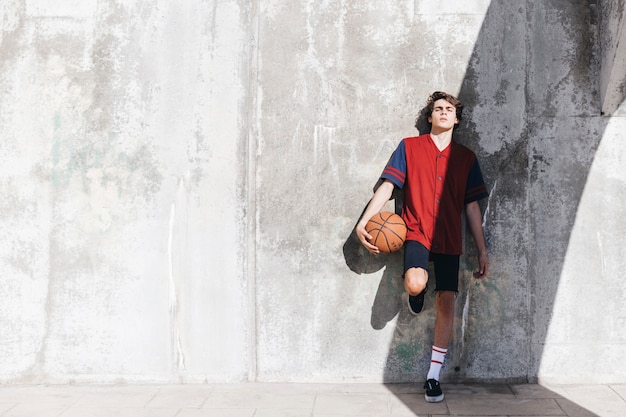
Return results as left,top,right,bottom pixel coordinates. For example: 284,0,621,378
404,240,460,292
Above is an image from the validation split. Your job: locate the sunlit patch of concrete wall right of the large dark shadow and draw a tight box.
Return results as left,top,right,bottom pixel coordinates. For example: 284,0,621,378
534,118,626,383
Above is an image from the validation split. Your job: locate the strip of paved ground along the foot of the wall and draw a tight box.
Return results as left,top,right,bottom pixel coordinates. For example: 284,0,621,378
0,383,626,417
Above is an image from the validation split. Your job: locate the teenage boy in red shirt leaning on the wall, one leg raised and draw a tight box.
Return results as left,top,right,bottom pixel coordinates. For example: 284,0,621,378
356,91,488,402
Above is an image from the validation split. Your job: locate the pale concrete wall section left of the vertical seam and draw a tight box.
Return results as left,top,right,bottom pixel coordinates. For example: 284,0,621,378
0,0,251,382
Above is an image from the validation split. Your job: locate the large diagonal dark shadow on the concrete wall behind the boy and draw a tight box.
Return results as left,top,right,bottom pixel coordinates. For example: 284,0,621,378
344,0,608,415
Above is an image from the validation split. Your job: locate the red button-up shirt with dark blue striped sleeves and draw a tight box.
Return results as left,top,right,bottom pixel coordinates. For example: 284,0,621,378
381,134,489,255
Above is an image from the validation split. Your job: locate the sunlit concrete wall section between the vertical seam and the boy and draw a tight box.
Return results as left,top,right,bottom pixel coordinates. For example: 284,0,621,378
257,2,498,380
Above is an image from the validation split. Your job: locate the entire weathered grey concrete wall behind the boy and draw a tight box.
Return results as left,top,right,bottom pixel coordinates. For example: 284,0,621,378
0,0,626,383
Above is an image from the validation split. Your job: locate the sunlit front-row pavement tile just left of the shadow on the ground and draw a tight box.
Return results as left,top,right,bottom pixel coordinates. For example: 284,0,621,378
313,394,389,417
